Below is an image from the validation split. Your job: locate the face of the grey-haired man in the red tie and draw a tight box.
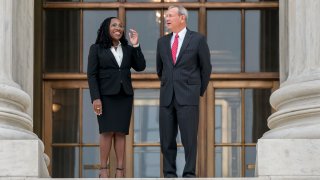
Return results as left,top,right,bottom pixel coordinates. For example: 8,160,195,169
166,8,185,33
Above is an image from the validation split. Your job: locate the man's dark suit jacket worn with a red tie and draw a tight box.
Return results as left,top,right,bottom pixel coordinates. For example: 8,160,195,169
157,29,212,106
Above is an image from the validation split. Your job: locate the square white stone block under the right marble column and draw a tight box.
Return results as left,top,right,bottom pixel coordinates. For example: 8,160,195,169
256,139,320,179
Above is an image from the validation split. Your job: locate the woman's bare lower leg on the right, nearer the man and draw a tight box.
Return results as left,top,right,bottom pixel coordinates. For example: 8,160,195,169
114,133,126,178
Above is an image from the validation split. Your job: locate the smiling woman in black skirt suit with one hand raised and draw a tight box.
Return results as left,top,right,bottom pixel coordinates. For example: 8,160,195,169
87,17,146,178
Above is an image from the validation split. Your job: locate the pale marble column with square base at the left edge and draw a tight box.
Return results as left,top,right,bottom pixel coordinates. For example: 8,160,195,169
0,0,49,178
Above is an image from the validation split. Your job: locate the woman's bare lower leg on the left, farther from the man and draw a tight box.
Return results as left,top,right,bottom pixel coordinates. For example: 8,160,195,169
99,132,114,178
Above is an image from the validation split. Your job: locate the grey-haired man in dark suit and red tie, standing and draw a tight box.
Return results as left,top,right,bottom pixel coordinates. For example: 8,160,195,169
157,6,212,178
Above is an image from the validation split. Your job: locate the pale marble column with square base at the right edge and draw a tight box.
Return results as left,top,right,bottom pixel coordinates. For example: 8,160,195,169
256,0,320,176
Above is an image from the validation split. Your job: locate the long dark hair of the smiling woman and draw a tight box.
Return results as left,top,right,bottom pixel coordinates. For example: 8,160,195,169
95,17,128,49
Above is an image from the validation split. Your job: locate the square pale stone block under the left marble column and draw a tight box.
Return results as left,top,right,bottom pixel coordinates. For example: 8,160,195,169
0,140,50,178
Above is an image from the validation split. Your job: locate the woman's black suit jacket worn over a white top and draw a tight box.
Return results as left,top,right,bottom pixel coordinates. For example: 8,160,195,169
87,44,146,101
